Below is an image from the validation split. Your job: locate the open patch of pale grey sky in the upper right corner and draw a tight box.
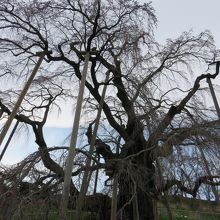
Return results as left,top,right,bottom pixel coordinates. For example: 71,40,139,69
152,0,220,48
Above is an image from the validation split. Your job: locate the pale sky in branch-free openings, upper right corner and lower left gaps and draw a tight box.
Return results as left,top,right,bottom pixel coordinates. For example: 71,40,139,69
2,0,220,165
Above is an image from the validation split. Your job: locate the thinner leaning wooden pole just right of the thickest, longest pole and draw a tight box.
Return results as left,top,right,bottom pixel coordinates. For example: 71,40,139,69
76,71,109,220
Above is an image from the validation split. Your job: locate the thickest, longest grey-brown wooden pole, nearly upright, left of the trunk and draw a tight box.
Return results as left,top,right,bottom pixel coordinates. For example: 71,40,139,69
59,52,90,220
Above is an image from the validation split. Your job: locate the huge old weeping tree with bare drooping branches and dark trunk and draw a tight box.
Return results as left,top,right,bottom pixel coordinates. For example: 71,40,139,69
0,0,219,220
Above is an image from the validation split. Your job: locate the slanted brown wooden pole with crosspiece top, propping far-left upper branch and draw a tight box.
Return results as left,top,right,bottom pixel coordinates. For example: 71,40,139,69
0,52,47,145
